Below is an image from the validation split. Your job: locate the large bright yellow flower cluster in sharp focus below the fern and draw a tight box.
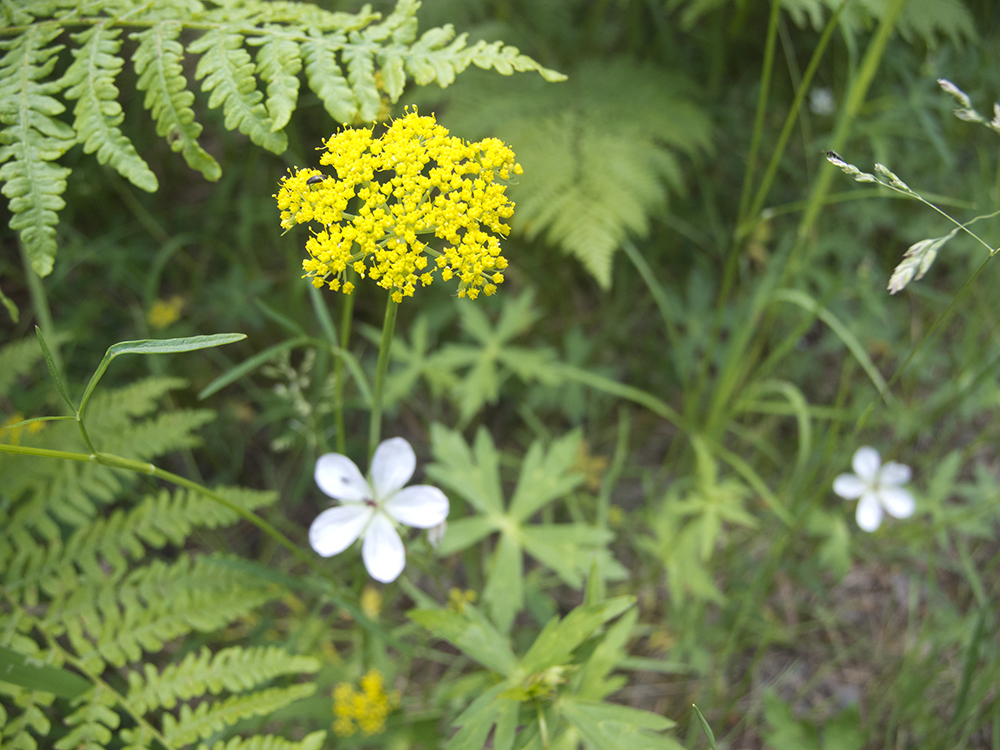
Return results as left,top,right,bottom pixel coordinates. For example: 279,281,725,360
275,110,523,302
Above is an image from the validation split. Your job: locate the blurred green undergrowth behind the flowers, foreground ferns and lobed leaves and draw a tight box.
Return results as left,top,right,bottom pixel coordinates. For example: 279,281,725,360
0,0,1000,750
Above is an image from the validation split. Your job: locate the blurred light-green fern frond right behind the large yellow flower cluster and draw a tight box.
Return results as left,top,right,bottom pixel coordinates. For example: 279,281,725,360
443,60,711,288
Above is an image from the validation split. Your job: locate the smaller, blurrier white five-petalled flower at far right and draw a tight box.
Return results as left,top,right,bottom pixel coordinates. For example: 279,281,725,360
833,445,916,531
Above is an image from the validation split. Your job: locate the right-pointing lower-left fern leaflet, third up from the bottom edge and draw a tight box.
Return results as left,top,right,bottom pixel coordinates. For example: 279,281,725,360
125,646,320,713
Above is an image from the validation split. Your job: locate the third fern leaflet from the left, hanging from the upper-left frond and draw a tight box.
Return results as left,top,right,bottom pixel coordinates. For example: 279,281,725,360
131,21,222,182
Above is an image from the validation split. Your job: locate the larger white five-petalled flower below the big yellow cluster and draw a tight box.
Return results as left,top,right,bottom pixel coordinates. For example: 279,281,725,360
309,438,448,583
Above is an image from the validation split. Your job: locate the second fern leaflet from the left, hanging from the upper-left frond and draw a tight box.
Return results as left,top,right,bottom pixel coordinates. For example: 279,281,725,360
64,22,159,193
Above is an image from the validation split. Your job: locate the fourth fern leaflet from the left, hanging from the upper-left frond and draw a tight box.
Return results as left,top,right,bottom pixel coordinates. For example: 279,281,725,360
189,30,288,154
